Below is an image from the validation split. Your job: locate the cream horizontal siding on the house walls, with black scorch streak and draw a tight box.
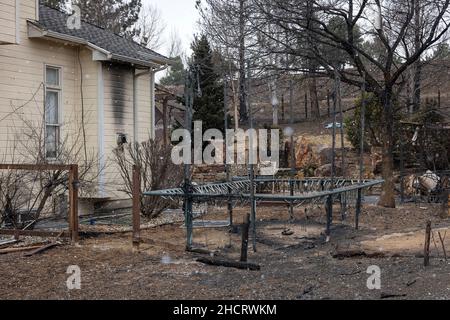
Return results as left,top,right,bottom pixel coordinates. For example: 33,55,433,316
0,0,159,199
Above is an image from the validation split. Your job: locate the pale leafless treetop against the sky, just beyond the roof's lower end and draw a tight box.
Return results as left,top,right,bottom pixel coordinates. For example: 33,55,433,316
135,3,166,50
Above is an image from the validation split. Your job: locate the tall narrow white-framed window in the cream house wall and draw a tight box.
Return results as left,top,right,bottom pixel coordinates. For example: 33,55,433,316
45,66,62,159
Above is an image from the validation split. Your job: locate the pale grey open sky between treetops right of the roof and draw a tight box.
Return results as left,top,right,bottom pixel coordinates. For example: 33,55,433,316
142,0,199,54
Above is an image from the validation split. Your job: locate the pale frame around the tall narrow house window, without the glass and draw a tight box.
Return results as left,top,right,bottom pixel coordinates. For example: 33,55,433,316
44,64,63,161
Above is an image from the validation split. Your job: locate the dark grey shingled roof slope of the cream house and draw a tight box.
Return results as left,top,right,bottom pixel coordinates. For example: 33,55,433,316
32,5,167,66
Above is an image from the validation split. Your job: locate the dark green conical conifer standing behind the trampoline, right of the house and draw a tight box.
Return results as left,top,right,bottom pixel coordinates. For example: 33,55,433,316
191,35,224,131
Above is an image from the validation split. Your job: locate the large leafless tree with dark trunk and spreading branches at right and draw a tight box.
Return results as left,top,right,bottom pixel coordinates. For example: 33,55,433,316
254,0,450,207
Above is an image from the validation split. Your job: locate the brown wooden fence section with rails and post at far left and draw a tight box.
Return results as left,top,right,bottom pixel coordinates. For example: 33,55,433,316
0,164,79,242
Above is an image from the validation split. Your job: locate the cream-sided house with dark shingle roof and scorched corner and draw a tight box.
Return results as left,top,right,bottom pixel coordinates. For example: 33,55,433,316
0,0,170,198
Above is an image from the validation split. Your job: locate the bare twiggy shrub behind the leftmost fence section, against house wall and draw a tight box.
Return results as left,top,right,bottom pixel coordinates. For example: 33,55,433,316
0,109,104,228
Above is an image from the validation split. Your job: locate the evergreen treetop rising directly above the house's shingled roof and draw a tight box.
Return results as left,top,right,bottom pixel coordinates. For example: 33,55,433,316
73,0,142,39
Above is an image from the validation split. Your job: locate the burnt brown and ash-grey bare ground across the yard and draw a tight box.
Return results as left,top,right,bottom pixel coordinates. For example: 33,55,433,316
0,204,450,300
